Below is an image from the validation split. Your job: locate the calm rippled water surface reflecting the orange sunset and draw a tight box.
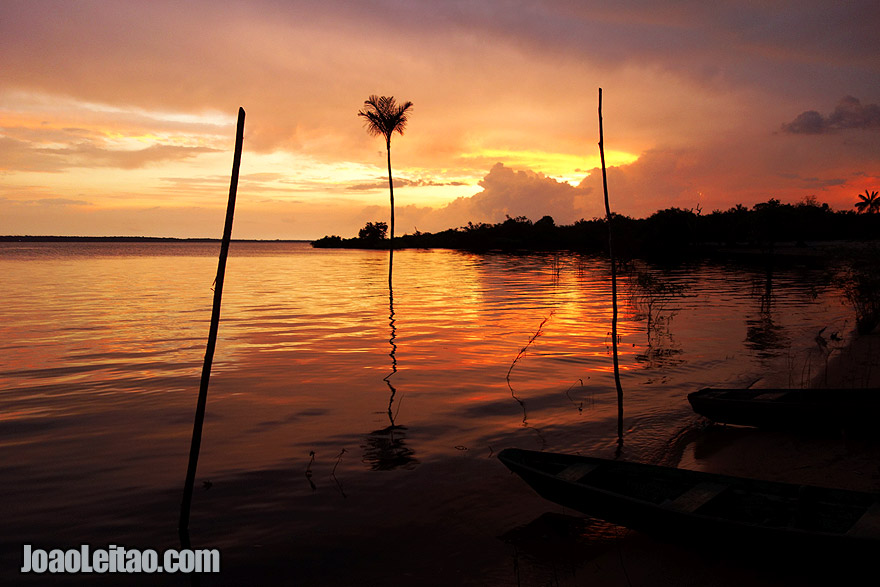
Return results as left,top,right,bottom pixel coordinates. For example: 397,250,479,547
0,243,853,585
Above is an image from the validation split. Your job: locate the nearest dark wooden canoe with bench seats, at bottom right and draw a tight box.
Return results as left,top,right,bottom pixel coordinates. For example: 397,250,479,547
498,448,880,553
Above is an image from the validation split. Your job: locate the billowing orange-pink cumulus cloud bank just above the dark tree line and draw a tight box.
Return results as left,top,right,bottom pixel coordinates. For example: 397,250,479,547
392,144,820,232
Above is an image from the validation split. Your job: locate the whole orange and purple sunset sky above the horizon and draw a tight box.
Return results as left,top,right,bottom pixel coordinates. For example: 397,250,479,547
0,0,880,239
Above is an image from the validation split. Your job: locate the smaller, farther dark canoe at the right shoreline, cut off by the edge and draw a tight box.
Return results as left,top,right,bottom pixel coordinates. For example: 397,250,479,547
688,387,880,431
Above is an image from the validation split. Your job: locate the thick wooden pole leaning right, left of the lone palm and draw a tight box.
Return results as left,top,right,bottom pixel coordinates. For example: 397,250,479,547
178,108,244,532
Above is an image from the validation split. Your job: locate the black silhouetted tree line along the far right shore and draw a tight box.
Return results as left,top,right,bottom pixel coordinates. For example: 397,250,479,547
312,198,880,258
